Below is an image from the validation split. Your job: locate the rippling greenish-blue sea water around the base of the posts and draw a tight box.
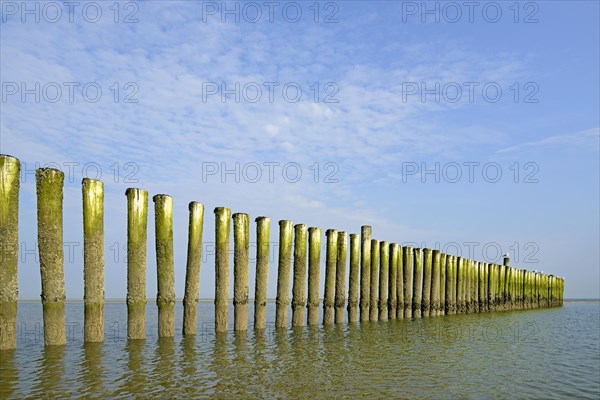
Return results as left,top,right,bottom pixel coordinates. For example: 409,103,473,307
0,302,600,399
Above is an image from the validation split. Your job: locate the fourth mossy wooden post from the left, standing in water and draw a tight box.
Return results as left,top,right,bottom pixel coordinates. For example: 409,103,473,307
125,188,148,339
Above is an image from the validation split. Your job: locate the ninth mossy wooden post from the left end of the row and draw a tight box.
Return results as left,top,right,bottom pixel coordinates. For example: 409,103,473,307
254,217,271,330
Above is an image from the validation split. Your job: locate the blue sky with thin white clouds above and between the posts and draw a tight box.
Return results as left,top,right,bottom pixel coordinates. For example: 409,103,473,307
0,0,600,301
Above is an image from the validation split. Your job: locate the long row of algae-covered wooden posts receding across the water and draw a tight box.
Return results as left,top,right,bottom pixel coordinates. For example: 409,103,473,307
0,155,564,349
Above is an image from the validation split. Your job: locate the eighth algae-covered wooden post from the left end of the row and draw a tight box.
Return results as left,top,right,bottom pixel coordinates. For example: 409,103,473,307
231,213,250,331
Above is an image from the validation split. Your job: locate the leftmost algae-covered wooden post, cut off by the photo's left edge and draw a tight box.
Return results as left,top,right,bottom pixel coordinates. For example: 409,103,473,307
0,154,21,350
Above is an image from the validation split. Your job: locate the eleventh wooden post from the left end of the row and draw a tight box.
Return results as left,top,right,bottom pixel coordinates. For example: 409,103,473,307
292,224,307,326
